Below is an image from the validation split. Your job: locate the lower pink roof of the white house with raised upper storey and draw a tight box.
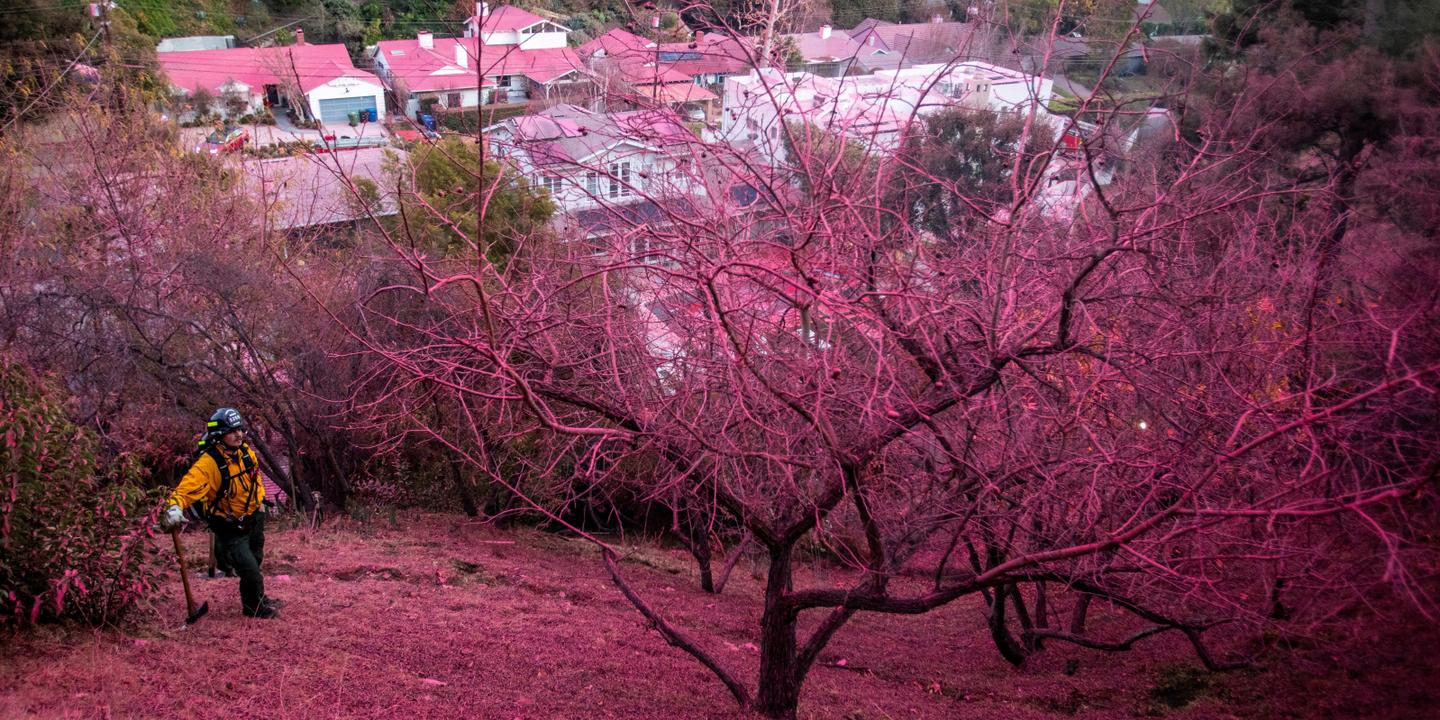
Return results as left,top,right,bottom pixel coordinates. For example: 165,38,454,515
377,37,585,92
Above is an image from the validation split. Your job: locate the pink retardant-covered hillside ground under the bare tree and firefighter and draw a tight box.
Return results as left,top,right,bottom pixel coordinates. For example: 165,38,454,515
0,516,1440,720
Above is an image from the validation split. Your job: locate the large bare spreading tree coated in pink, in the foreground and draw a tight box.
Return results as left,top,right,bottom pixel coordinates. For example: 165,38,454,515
331,14,1440,717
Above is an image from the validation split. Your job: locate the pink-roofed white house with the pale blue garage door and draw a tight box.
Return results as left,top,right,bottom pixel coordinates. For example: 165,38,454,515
156,30,384,124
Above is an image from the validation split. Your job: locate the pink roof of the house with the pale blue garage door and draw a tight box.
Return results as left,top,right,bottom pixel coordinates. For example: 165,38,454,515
156,45,380,92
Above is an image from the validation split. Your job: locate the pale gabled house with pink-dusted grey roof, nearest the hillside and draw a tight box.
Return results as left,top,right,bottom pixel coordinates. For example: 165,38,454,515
485,104,704,236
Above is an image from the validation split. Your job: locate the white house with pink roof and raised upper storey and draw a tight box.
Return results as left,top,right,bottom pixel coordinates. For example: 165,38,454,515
374,3,585,117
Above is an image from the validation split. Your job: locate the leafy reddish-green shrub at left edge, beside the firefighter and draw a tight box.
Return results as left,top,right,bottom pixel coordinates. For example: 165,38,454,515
0,360,158,625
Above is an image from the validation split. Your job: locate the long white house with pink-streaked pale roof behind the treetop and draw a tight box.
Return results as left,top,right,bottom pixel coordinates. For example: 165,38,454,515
720,62,1054,166
